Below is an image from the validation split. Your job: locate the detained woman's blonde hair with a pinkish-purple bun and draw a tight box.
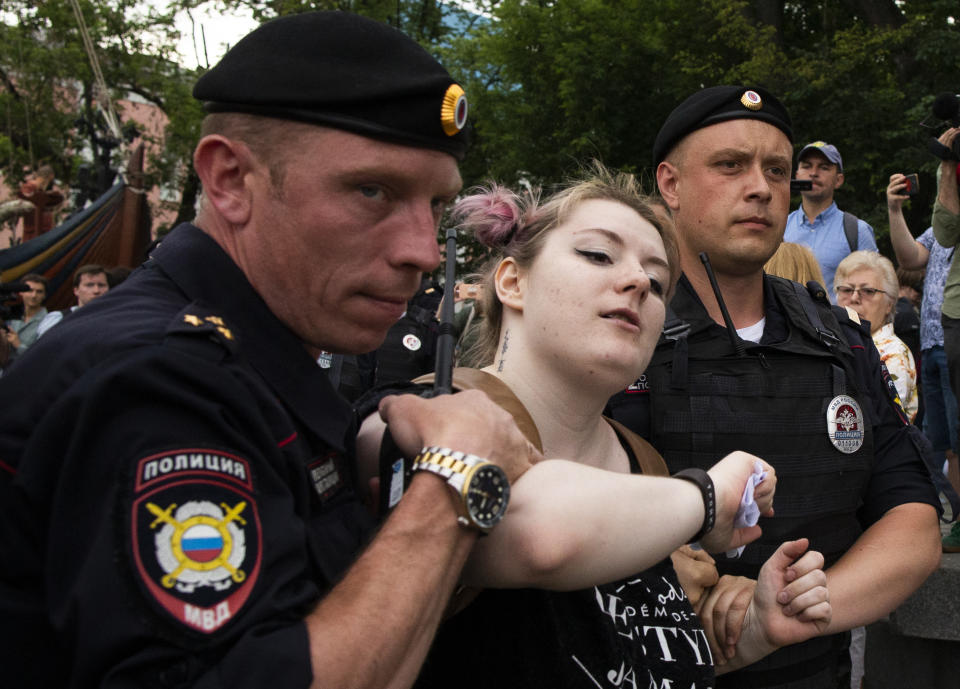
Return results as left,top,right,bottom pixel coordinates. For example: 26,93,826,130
453,161,680,367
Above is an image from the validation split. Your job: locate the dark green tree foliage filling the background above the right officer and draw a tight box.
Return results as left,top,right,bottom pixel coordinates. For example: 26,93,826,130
444,0,960,260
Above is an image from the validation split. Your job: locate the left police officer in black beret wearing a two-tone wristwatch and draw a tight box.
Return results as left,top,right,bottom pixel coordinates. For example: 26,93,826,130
0,12,532,688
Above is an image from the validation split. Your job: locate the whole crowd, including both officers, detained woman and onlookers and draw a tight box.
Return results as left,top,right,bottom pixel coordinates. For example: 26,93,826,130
0,12,960,689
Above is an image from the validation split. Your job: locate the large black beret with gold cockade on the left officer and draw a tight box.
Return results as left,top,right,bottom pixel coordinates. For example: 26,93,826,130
193,12,468,159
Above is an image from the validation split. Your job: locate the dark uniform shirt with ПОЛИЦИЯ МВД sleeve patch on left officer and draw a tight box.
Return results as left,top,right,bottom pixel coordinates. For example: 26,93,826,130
0,225,372,688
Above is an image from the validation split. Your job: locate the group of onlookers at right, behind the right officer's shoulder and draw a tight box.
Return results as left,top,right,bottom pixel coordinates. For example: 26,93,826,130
765,137,960,553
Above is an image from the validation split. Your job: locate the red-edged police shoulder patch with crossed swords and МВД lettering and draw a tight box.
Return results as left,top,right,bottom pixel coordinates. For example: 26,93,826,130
130,448,263,634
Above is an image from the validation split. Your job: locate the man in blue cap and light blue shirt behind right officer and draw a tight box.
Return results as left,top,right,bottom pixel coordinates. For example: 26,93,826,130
783,141,877,303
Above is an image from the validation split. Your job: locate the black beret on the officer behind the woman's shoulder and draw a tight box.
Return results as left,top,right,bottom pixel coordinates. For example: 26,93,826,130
653,86,793,165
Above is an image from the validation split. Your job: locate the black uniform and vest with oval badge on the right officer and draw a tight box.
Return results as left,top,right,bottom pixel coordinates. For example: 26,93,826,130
607,276,940,689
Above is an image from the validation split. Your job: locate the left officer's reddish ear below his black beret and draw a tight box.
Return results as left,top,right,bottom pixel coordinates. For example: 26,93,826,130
193,134,256,226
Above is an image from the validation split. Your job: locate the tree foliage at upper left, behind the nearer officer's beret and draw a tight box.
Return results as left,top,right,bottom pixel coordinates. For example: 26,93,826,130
0,0,201,231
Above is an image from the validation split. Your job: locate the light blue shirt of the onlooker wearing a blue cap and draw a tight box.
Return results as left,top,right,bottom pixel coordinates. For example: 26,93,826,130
783,203,877,303
